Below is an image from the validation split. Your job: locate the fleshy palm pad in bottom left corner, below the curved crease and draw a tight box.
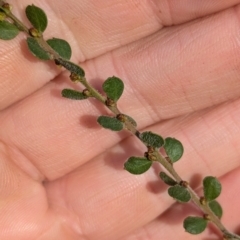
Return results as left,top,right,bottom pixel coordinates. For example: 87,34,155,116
0,142,55,240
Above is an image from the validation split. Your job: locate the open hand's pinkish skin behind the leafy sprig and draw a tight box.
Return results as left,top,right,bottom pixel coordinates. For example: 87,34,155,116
0,0,240,240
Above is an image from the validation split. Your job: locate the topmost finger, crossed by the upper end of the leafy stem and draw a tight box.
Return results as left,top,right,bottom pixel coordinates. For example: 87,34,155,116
0,0,239,109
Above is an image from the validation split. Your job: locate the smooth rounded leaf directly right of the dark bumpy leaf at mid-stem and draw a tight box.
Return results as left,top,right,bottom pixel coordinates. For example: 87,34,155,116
163,137,183,163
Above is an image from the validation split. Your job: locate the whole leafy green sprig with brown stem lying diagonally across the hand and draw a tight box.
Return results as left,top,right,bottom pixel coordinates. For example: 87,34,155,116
0,1,240,240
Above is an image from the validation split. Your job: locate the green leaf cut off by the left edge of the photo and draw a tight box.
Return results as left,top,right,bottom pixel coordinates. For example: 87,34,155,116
0,21,19,40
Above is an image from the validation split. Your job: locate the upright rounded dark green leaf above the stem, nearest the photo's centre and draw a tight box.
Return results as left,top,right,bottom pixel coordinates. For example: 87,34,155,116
102,76,124,101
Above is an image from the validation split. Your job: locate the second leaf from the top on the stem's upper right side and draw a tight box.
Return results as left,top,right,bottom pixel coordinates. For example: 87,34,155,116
47,38,72,60
